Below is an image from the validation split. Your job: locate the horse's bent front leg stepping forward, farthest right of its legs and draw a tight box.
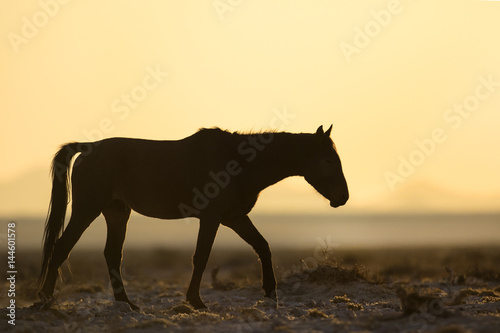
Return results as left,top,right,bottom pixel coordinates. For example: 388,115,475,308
223,216,277,300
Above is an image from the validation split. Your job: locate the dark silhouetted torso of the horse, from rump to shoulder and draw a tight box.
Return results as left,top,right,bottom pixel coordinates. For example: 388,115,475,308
72,131,248,219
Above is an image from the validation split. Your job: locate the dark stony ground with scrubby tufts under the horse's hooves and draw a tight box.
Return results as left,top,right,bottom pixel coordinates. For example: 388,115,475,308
0,247,500,333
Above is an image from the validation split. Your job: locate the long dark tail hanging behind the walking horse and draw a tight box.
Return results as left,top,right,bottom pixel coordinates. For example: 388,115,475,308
38,142,79,288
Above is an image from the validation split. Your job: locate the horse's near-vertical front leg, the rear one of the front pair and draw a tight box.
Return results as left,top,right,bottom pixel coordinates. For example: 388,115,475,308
186,220,219,309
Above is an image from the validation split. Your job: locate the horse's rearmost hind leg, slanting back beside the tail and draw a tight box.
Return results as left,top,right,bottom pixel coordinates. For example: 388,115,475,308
39,208,100,300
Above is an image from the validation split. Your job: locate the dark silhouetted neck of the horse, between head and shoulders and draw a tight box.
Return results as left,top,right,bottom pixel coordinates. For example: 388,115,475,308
239,133,312,193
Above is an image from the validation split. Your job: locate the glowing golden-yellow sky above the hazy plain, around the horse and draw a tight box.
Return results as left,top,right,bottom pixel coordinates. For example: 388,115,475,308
0,0,500,214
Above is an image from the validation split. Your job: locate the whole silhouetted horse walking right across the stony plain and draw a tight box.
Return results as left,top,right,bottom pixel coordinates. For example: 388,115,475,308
38,126,349,310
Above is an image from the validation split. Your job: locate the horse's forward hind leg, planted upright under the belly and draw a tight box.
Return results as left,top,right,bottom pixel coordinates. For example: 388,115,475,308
102,200,139,310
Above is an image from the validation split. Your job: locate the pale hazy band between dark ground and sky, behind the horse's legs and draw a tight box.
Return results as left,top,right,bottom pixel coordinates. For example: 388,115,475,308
0,212,500,251
